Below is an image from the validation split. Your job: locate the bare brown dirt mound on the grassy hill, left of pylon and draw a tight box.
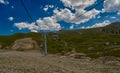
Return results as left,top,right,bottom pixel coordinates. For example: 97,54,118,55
12,38,39,50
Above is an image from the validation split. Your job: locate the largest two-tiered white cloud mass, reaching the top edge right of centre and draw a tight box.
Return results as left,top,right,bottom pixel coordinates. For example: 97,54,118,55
54,0,100,24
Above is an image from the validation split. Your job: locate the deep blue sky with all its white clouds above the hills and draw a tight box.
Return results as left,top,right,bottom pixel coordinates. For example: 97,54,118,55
0,0,120,35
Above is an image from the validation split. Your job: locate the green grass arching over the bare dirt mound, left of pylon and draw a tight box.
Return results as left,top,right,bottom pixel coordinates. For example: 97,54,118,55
0,33,41,47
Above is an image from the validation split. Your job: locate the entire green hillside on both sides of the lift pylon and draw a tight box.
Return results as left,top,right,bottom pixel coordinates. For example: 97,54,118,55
0,22,120,58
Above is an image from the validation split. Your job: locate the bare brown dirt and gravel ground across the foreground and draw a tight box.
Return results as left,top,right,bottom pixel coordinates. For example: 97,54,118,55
0,51,120,73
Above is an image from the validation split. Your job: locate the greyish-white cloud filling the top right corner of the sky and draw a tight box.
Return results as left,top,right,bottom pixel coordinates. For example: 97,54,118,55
104,0,120,12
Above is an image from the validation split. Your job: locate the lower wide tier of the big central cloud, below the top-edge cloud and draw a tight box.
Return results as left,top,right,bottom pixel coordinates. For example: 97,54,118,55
54,8,99,24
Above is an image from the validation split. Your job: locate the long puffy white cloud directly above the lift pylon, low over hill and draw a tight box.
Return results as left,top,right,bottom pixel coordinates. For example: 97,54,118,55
14,17,61,32
